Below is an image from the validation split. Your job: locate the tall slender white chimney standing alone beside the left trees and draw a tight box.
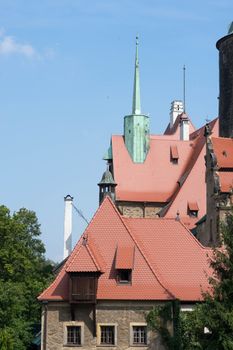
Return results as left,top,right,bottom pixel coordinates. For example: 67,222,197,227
63,194,73,259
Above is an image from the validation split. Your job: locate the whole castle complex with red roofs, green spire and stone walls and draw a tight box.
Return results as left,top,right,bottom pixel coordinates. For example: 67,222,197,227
39,23,233,350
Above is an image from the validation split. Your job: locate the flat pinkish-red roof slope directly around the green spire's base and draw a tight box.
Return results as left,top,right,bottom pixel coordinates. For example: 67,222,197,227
112,136,193,202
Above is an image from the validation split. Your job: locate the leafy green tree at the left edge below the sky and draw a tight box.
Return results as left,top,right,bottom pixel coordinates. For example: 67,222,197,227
0,206,53,350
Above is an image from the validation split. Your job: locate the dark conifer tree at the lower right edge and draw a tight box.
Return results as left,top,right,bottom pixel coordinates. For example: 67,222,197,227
183,214,233,350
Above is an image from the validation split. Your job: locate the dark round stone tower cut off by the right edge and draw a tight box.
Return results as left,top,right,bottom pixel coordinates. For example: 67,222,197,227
216,22,233,137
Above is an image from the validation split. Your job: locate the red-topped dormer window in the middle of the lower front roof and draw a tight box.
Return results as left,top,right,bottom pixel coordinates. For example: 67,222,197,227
115,246,134,284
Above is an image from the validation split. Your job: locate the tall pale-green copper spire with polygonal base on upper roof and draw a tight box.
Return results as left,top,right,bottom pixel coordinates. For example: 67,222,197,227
124,37,150,163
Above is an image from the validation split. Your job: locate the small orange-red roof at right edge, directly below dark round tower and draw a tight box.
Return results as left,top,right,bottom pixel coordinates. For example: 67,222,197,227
211,137,233,169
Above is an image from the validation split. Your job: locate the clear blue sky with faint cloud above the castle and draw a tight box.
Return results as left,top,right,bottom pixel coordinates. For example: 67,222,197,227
0,0,233,261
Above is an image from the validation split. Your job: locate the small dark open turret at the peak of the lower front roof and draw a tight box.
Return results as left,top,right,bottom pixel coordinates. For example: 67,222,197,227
98,166,117,204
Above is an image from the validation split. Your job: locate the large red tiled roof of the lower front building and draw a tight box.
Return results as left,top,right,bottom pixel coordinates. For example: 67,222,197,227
39,197,211,301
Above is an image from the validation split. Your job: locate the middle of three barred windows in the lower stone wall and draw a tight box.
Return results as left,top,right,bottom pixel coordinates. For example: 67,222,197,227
97,323,117,346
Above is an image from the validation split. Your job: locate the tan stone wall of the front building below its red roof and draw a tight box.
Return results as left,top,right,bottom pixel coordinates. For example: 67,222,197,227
42,301,164,350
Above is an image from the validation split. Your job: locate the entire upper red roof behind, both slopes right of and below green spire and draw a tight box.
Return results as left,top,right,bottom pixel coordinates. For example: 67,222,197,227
112,119,218,229
